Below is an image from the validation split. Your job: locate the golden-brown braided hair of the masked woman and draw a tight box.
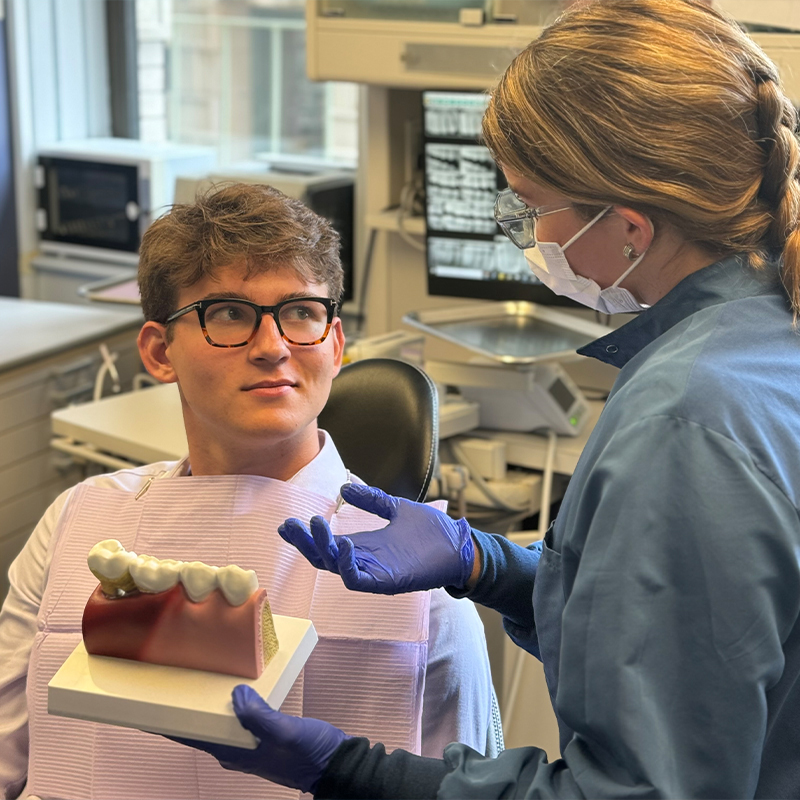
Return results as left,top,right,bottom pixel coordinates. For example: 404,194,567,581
483,0,800,316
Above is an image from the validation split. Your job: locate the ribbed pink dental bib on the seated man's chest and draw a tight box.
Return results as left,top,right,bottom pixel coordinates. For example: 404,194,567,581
26,475,430,800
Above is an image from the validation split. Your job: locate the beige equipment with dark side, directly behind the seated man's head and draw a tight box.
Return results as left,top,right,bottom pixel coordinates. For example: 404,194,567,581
175,166,354,300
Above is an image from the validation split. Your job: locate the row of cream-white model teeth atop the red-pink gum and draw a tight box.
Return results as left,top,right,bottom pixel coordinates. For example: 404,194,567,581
87,539,258,606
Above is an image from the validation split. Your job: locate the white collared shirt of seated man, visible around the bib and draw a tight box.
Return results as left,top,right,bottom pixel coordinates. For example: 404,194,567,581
0,431,492,798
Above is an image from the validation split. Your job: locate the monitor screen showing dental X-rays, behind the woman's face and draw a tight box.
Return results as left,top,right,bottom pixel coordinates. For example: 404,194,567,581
422,90,576,306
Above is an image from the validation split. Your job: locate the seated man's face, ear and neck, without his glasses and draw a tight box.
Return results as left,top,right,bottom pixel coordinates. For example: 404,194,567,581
139,264,344,478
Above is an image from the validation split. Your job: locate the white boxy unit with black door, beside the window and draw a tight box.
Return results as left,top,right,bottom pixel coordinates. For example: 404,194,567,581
34,138,216,265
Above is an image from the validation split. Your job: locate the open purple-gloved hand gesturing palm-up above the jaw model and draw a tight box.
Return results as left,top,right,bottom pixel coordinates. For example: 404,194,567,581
278,484,475,594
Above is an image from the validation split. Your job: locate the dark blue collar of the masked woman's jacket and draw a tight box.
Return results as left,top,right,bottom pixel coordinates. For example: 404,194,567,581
578,255,788,368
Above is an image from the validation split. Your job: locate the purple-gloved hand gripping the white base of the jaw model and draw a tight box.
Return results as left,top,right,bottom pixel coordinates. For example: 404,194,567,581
169,684,350,793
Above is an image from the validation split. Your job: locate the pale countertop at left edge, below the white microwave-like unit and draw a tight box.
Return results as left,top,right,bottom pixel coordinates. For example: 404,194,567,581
0,297,142,372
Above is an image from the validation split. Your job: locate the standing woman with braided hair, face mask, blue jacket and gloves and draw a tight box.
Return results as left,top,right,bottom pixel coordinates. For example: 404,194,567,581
177,0,800,798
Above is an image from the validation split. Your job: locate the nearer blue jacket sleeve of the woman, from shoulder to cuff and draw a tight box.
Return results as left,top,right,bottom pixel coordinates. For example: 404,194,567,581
438,417,800,798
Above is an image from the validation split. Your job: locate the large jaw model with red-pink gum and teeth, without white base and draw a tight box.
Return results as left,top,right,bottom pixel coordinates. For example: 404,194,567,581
83,539,278,678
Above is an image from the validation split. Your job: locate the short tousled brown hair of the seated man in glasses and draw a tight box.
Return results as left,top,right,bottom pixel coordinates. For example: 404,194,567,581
139,183,344,323
